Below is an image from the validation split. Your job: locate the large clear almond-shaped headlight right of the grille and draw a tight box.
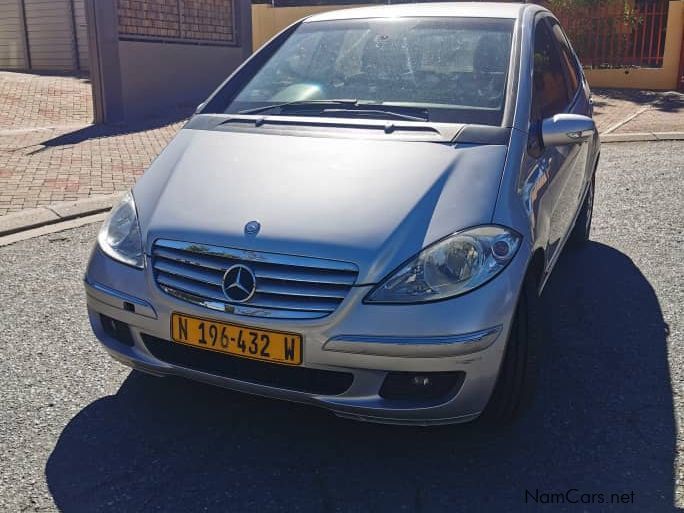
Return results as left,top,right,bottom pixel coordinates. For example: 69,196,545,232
365,226,522,303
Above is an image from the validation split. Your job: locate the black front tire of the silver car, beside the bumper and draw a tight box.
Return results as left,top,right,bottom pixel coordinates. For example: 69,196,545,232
480,272,545,426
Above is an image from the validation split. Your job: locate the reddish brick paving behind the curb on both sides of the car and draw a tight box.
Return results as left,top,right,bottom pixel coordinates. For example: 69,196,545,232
0,72,684,216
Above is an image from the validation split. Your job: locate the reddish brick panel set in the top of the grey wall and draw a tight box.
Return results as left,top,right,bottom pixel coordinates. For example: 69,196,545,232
118,0,236,43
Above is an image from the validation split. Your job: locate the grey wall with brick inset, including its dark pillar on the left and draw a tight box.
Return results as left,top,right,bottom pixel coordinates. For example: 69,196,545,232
87,0,252,123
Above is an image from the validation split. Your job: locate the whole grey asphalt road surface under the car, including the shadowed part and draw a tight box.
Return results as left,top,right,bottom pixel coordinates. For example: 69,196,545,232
0,138,684,513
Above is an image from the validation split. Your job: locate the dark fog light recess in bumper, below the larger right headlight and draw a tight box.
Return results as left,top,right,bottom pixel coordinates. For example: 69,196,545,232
380,372,465,401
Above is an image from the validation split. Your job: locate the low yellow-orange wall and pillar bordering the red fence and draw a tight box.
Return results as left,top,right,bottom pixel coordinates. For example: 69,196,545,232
585,0,684,90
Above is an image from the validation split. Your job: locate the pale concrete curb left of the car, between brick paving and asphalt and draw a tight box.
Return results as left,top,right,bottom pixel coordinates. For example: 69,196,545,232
0,193,123,237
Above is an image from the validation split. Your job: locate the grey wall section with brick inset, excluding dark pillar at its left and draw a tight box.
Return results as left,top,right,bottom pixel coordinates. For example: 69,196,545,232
118,0,251,119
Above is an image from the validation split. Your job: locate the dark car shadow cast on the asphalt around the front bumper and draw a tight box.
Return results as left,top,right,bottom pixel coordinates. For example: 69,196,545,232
46,243,675,513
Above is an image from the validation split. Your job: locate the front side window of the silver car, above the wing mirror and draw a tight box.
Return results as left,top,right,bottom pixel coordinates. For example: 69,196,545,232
532,20,569,121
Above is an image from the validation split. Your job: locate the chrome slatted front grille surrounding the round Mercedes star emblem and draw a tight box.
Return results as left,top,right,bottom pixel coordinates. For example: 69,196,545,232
152,240,358,319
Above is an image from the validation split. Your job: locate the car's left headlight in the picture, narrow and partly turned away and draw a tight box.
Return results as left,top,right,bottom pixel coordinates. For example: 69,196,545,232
97,192,144,269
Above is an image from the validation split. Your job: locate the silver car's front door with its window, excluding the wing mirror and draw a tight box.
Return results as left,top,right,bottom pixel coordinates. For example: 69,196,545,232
528,16,586,268
